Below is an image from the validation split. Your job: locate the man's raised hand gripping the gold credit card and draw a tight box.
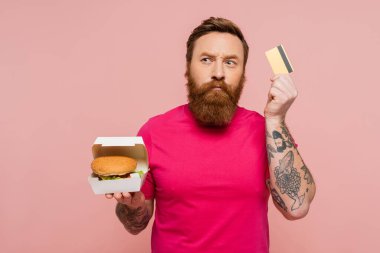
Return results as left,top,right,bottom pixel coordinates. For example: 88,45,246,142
264,74,298,122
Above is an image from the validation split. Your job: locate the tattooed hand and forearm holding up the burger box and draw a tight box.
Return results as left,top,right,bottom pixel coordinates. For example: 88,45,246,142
106,192,153,235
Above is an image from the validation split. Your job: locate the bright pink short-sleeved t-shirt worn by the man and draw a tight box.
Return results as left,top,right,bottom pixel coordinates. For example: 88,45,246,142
138,104,269,253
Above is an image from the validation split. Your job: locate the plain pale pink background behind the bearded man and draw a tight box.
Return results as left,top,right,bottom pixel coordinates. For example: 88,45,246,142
0,0,380,253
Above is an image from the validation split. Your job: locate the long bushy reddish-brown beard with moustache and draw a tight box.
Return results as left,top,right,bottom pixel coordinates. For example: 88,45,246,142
185,69,245,127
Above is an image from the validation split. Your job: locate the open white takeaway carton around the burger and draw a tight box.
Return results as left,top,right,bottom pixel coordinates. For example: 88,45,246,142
88,136,149,194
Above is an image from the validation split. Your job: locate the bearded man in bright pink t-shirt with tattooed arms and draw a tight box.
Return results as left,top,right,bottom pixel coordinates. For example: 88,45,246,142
106,17,315,253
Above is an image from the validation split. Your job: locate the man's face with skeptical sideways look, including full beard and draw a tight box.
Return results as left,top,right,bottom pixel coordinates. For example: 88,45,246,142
185,32,245,127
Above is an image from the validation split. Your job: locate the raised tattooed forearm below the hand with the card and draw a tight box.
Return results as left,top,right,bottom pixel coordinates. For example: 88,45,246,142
265,119,316,220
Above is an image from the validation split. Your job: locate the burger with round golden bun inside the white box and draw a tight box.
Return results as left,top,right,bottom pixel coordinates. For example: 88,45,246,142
91,156,137,180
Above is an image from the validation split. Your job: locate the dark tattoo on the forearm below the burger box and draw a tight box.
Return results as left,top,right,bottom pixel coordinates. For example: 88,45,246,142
116,203,150,235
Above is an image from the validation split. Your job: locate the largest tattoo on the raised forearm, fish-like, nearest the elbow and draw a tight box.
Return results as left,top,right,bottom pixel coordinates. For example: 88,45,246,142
274,151,305,211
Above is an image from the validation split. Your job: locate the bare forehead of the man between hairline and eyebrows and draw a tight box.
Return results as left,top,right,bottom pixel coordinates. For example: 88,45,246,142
194,32,244,58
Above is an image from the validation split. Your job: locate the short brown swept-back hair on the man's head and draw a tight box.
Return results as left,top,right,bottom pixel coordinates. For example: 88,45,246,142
186,17,249,69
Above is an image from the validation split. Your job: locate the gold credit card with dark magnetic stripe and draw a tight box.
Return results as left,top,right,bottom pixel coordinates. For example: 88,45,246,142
265,45,293,75
